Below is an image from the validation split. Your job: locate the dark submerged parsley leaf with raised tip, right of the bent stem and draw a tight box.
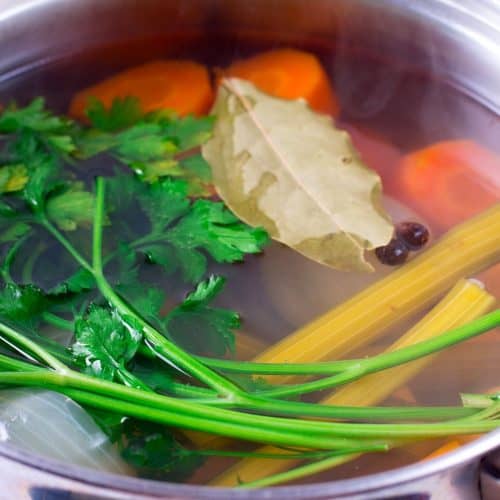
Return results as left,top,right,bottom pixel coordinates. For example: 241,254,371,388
165,276,240,356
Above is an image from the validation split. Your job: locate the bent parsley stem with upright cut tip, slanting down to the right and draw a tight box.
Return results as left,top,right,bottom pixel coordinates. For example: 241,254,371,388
91,177,245,400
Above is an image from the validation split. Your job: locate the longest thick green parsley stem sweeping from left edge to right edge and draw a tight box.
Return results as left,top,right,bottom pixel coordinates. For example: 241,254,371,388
0,350,494,449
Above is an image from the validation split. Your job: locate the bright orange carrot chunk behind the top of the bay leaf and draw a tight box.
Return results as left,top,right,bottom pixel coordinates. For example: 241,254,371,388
221,49,339,116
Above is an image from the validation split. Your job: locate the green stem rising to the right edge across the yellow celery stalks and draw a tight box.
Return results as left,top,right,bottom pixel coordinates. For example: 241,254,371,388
259,309,500,398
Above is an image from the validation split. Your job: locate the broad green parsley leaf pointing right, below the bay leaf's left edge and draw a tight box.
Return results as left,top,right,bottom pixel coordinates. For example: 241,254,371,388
108,176,269,283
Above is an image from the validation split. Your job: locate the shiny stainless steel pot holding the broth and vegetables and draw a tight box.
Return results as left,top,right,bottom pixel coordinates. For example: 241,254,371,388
0,0,500,500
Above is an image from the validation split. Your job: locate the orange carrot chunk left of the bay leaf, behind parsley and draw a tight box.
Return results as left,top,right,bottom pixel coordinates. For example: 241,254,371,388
69,60,214,120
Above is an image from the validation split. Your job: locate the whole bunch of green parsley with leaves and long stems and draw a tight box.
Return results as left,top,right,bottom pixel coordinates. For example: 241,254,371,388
0,98,500,486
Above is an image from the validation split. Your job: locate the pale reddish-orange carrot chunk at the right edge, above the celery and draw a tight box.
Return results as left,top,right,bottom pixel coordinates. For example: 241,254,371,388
396,140,500,229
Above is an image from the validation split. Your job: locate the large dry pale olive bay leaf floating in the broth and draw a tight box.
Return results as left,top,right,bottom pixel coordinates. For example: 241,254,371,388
202,78,393,271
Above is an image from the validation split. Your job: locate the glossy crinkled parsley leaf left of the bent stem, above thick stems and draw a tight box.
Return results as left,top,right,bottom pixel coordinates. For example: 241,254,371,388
72,305,142,385
